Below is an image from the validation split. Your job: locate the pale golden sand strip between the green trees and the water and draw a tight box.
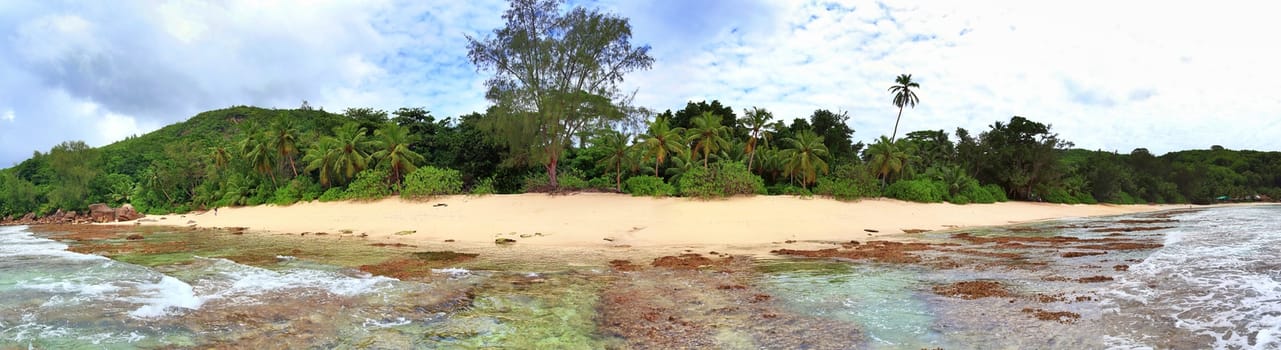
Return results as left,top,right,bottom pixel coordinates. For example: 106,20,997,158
122,194,1186,253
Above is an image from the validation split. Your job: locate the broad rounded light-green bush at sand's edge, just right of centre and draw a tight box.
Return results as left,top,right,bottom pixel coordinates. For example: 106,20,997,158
679,162,766,199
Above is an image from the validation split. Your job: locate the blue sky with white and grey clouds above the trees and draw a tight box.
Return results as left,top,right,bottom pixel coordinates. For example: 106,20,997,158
0,0,1281,167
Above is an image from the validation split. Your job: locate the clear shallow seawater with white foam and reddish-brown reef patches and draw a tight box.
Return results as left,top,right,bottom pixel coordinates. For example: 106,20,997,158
0,206,1281,349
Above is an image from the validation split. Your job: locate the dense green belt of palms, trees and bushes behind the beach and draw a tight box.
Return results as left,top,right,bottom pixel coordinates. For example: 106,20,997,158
0,0,1281,217
